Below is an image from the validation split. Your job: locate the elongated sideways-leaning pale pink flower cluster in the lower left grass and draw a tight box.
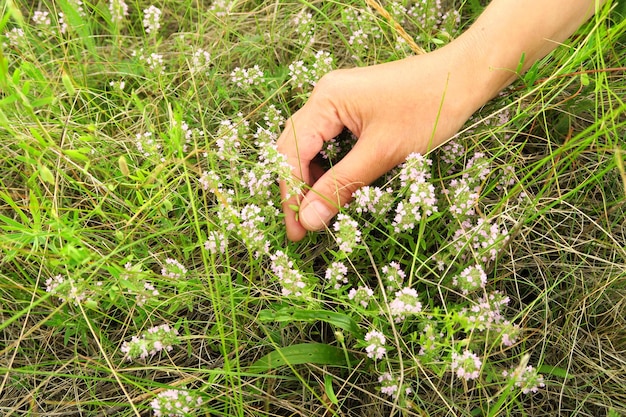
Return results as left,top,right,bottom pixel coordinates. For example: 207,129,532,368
120,324,180,361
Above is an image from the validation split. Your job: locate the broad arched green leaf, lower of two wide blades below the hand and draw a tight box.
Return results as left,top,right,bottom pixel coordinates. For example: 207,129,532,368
248,343,348,373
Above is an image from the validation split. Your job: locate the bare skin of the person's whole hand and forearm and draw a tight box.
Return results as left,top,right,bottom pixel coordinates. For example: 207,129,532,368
278,0,600,241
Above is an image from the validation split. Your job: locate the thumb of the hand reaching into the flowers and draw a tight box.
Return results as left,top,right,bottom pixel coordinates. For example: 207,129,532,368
299,138,395,231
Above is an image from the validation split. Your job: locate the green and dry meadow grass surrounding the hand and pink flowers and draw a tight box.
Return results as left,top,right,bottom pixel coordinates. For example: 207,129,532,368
0,0,626,416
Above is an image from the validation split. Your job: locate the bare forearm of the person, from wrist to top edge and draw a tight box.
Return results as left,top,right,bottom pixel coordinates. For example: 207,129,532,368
455,0,603,101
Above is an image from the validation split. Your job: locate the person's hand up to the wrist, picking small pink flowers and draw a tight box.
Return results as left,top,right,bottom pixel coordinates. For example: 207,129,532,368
278,48,489,241
